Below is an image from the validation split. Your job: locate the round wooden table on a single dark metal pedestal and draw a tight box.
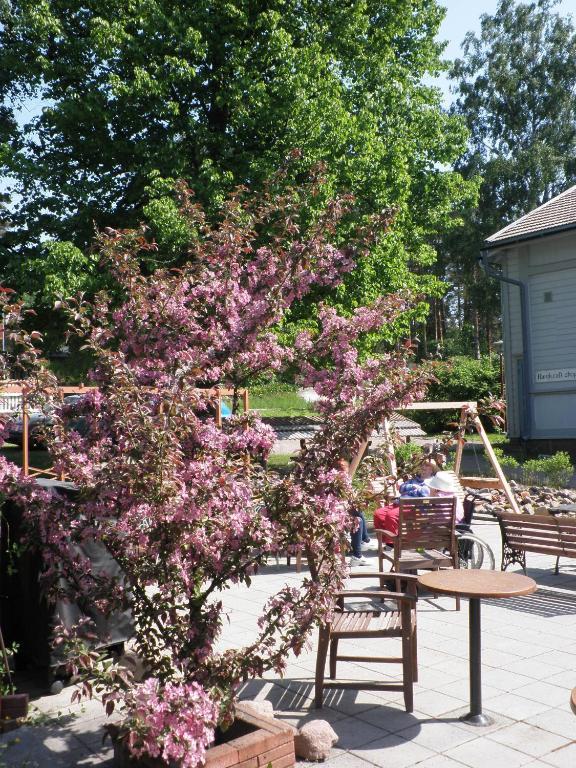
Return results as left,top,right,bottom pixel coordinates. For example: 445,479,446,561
418,568,538,725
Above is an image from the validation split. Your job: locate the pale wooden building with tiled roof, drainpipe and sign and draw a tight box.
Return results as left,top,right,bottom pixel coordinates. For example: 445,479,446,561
482,186,576,449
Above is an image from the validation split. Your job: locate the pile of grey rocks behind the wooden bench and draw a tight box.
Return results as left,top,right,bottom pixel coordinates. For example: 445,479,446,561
470,480,576,517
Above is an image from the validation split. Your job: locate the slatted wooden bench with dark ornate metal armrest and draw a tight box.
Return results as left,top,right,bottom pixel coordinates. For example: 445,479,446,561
497,512,576,573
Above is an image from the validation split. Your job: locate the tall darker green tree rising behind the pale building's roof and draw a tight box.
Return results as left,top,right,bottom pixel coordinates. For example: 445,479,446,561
443,0,576,352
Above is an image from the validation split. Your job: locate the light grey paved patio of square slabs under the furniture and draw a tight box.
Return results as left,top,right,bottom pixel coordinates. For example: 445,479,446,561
0,522,576,768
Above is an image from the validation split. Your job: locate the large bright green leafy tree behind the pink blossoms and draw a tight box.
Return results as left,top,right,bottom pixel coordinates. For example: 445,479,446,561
0,0,468,336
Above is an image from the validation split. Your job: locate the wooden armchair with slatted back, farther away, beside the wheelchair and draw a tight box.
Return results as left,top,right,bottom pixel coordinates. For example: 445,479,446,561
376,496,460,611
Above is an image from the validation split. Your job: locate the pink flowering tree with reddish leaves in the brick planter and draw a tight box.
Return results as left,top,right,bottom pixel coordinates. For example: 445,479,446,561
0,171,423,768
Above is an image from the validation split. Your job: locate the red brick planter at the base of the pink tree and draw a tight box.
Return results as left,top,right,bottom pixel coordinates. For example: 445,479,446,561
114,702,296,768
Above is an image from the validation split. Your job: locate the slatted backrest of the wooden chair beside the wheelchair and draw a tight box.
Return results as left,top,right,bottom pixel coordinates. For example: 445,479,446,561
396,496,456,552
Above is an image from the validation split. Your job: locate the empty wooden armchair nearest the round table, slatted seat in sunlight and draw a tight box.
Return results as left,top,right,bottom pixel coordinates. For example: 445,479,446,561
315,572,418,712
